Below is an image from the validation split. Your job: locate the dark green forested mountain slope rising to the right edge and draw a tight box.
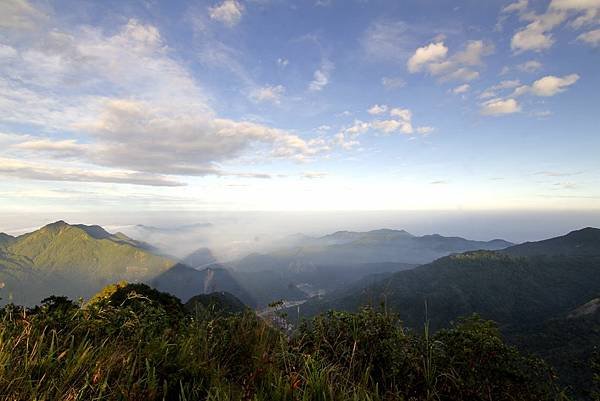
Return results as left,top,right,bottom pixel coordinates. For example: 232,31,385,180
301,228,600,397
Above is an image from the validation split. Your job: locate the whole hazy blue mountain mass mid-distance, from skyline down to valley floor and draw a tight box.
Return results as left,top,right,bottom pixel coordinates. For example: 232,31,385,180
230,229,512,304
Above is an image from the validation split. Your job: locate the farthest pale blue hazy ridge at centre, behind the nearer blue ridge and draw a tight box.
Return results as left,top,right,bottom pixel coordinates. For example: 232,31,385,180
235,229,513,271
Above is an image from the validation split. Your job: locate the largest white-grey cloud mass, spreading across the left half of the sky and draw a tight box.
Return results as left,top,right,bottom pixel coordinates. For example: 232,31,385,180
0,9,329,185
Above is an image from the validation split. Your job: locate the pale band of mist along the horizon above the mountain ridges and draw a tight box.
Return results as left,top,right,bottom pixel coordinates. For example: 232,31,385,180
0,210,600,262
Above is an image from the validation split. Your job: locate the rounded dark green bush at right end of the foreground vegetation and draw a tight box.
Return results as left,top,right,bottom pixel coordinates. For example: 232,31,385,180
433,315,559,401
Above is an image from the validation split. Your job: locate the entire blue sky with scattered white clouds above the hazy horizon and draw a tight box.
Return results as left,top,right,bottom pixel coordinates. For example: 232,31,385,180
0,0,600,212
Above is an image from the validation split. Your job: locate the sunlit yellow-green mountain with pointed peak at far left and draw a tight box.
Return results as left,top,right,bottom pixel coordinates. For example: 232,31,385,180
0,221,175,305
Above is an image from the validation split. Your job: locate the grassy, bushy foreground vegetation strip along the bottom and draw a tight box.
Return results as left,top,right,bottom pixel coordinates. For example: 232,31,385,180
0,284,592,401
